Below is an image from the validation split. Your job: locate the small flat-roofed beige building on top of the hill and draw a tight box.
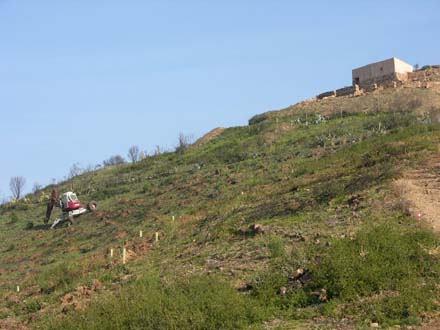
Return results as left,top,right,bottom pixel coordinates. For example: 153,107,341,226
352,57,413,85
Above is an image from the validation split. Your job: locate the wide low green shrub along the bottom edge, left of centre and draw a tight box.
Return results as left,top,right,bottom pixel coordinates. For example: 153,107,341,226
44,276,263,330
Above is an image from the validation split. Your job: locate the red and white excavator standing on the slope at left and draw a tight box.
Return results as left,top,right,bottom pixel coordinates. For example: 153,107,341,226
44,189,98,229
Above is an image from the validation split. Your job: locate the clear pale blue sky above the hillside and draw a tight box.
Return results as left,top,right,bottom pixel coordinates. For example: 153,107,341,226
0,0,440,199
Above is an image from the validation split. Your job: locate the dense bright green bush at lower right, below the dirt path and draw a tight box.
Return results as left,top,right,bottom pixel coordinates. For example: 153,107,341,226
313,225,439,301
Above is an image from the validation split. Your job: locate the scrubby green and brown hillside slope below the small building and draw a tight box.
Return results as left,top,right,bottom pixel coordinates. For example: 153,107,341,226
0,84,440,329
